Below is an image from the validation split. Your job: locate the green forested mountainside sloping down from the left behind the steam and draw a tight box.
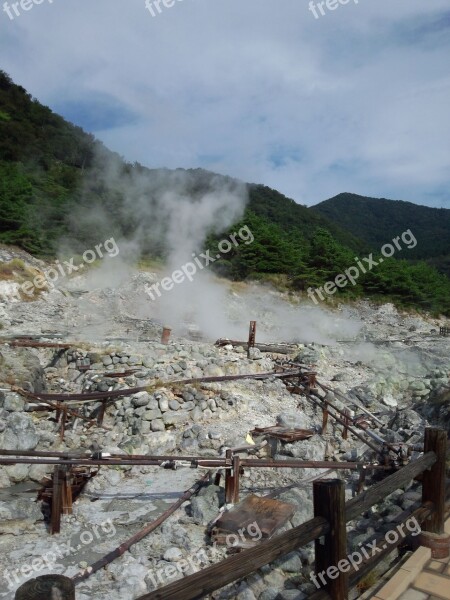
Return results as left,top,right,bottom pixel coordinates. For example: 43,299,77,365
0,71,450,315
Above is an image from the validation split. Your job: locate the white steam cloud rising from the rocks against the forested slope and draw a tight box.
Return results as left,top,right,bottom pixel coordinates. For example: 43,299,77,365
58,154,359,344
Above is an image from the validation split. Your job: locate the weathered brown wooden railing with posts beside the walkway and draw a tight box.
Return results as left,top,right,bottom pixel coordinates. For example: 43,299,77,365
138,428,447,600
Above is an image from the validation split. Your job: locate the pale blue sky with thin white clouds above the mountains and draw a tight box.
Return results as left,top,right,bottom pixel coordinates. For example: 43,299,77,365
0,0,450,208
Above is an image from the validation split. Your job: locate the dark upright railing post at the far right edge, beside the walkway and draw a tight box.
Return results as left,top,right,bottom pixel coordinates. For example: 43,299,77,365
422,427,447,533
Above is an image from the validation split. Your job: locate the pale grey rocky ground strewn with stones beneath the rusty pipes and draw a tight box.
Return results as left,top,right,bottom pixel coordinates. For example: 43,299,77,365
0,250,450,600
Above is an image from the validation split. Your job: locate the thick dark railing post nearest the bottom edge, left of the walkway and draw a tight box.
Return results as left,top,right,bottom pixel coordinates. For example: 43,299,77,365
313,479,350,600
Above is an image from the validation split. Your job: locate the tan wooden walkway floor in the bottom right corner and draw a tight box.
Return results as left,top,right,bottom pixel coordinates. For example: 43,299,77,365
371,519,450,600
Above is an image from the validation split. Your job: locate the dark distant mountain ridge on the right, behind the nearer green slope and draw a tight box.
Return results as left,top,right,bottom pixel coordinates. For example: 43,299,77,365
310,193,450,276
